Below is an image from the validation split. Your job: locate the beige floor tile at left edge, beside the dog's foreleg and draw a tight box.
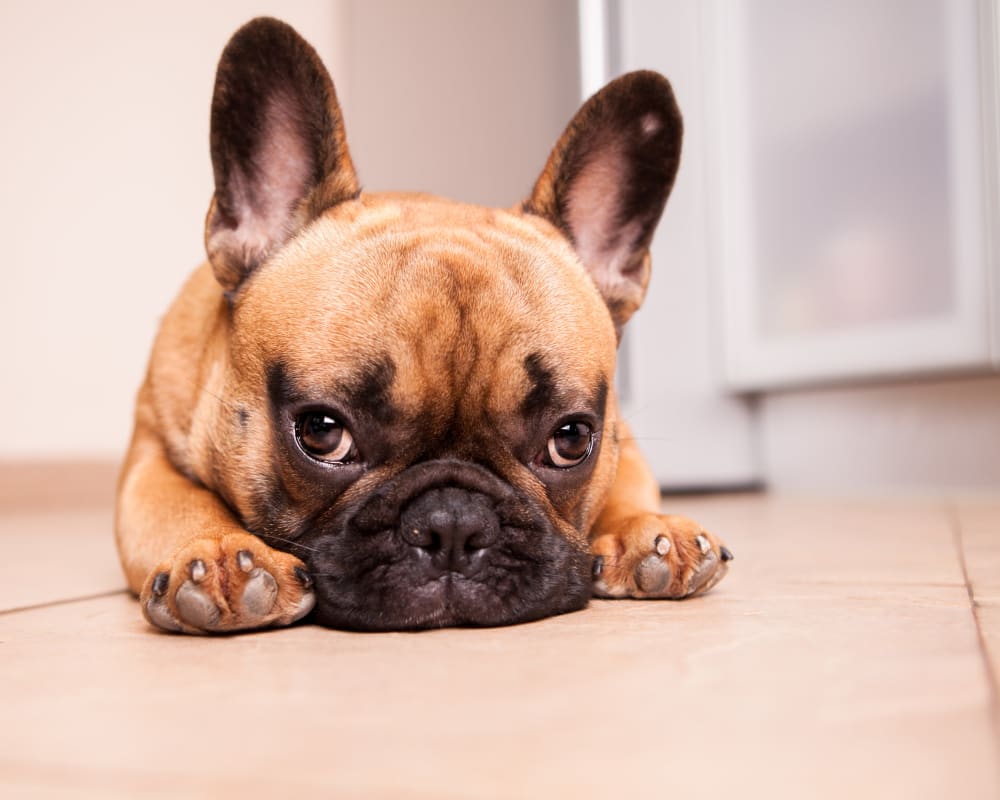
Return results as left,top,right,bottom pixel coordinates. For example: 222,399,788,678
0,508,125,611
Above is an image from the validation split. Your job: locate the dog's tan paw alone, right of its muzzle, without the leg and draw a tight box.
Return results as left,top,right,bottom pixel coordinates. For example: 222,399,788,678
591,514,733,600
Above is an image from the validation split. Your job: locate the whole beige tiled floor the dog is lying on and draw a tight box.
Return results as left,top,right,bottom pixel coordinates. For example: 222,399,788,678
0,482,1000,800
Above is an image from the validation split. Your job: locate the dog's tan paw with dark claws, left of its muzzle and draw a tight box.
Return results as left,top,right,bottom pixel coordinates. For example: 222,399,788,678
139,533,316,633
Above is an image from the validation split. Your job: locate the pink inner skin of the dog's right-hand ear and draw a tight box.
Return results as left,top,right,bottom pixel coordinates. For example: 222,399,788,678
566,138,640,292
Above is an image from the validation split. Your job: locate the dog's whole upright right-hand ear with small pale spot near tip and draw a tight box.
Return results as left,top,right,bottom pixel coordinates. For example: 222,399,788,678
523,71,683,336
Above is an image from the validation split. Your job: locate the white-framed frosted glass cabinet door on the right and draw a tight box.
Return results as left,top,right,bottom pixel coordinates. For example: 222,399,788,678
704,0,997,389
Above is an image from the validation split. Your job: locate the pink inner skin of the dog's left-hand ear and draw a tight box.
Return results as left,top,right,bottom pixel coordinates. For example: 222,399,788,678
232,91,315,252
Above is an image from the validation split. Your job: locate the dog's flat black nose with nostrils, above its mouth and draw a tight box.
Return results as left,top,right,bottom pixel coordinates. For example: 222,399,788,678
400,487,499,575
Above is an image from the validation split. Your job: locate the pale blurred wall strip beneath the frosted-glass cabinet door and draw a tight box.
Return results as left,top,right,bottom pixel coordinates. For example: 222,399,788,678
760,377,1000,493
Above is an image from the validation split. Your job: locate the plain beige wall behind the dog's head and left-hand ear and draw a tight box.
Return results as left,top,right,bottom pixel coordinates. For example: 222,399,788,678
0,0,578,460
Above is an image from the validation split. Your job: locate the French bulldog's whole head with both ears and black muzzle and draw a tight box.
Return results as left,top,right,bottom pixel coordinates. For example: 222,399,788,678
197,19,681,629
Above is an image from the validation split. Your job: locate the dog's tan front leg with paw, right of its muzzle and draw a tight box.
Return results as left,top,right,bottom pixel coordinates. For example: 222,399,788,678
591,425,733,599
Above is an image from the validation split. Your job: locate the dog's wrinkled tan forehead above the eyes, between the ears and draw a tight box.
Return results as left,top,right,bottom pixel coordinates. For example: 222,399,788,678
234,196,616,413
